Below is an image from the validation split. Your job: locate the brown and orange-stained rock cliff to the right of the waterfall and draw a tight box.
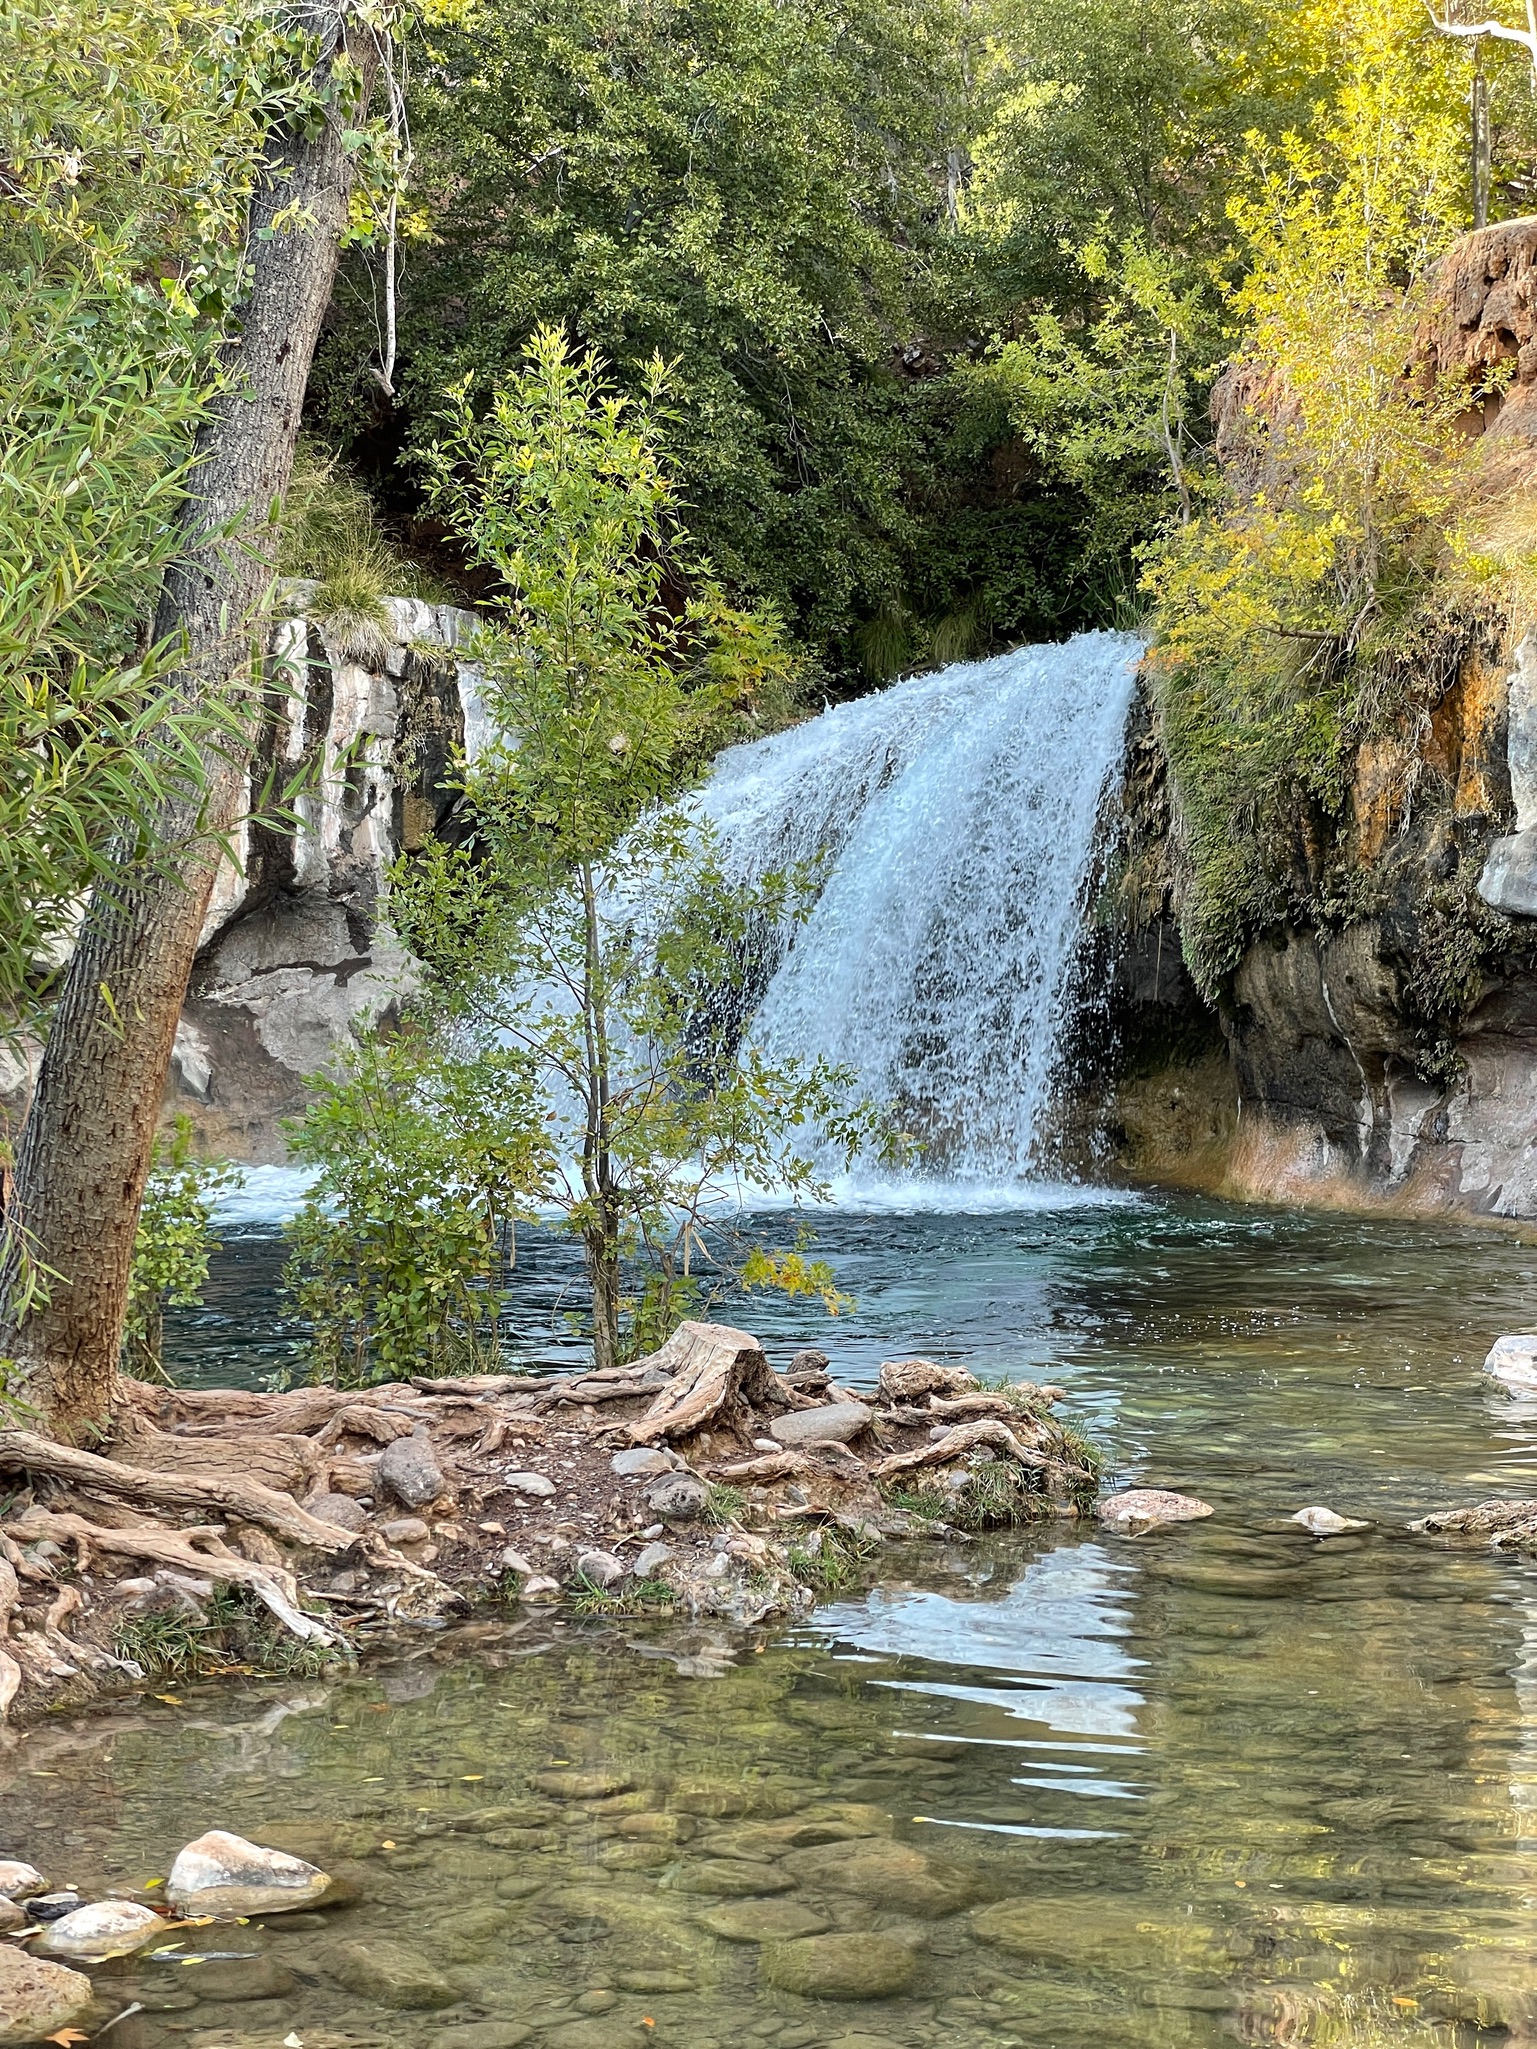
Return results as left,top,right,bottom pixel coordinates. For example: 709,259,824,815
1107,219,1537,1217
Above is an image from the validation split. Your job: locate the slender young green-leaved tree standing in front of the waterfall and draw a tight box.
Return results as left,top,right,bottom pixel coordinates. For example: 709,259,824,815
301,330,885,1367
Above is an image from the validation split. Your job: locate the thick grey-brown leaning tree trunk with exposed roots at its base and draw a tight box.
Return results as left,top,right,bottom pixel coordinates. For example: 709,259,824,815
0,12,379,1436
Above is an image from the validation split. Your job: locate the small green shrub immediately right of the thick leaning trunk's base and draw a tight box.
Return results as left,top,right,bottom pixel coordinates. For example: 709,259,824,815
123,1117,244,1387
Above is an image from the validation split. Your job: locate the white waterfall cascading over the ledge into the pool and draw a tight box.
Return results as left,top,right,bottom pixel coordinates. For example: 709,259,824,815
699,633,1141,1182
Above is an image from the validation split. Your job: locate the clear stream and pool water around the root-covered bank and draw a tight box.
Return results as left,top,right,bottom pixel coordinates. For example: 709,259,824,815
24,1195,1537,2049
